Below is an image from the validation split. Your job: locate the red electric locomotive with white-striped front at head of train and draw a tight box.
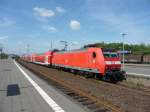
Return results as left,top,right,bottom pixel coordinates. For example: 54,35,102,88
52,48,125,82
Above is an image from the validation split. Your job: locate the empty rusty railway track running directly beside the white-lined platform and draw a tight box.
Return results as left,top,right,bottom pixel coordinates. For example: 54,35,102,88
19,59,123,112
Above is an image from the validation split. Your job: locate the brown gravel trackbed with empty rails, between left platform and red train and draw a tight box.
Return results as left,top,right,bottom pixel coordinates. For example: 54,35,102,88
17,59,150,112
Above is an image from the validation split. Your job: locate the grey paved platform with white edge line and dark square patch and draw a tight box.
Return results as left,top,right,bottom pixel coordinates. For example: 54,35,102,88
0,59,87,112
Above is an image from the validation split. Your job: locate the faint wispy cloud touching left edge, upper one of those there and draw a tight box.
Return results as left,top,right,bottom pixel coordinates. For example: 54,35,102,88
0,17,15,27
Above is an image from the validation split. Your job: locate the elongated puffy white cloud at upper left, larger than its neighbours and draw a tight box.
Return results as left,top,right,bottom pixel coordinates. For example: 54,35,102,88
33,7,55,18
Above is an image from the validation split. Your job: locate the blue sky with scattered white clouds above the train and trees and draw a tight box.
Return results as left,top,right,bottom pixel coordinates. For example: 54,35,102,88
0,0,150,54
